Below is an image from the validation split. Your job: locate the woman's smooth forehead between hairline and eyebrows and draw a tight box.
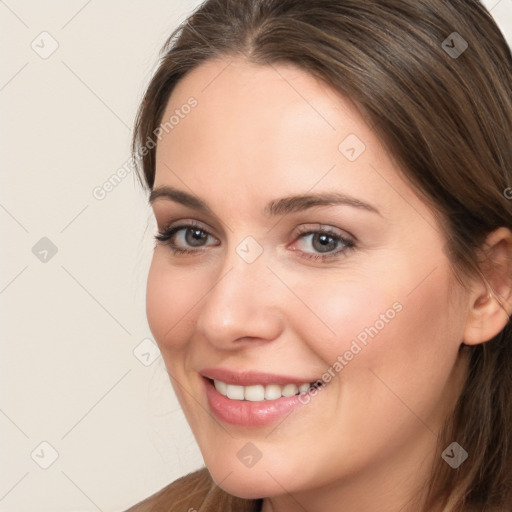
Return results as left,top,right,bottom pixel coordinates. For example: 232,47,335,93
155,57,428,224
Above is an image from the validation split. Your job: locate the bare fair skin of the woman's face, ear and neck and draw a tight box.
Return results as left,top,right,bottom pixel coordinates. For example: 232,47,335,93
147,58,509,512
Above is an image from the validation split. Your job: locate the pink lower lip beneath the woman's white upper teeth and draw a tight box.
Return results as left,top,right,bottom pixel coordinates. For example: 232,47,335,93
203,378,305,427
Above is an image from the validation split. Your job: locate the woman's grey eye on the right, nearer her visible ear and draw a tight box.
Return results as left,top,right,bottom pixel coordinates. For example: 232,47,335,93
292,228,356,260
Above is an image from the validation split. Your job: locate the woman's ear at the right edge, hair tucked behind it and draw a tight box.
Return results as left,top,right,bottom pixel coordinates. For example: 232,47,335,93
463,227,512,345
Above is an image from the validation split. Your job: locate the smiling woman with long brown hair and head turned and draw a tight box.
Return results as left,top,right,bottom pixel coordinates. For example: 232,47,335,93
125,0,512,512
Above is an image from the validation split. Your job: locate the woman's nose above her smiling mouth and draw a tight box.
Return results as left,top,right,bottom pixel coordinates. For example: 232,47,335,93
196,245,284,350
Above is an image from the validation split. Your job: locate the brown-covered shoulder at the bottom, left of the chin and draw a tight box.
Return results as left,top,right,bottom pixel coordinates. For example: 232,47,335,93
125,467,261,512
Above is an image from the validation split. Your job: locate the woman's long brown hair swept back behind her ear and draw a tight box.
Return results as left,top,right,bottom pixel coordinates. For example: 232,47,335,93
132,0,512,512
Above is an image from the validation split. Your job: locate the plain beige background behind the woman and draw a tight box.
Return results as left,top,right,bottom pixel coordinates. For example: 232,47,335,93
0,0,512,512
